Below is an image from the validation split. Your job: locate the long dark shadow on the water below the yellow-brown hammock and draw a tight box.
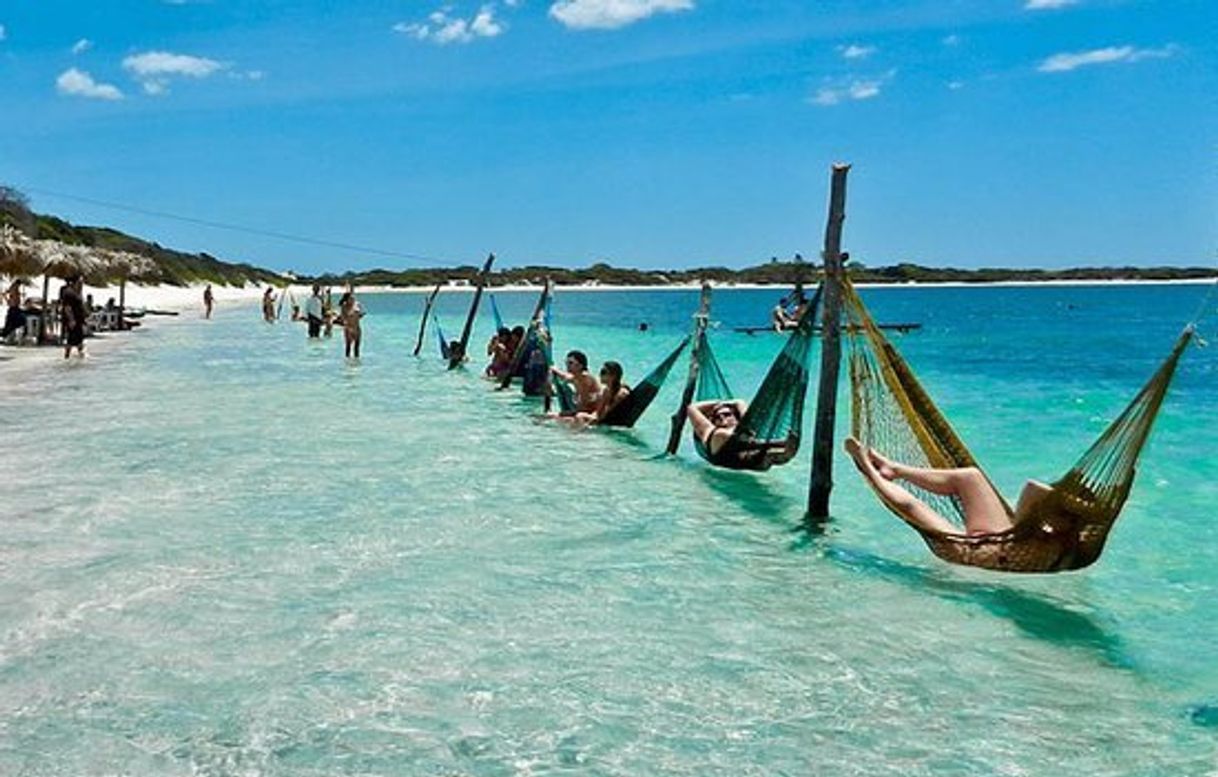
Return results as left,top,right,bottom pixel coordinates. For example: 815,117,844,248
794,526,1136,669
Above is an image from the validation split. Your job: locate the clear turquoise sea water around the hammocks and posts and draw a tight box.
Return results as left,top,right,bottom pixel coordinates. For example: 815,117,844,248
0,286,1218,776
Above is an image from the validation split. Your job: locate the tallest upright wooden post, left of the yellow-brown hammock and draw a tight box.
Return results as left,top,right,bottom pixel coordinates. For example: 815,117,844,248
808,164,850,521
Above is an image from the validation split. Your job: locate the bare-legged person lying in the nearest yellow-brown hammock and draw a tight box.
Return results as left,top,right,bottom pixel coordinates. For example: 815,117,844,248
845,437,1049,536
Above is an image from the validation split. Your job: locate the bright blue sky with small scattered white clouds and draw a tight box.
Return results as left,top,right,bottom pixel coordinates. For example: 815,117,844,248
0,0,1218,272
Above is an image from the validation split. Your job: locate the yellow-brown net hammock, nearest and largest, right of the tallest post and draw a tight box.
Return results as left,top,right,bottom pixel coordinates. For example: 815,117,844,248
843,280,1192,572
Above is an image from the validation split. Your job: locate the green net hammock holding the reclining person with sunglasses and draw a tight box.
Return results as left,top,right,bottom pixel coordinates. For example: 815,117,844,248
693,287,821,471
